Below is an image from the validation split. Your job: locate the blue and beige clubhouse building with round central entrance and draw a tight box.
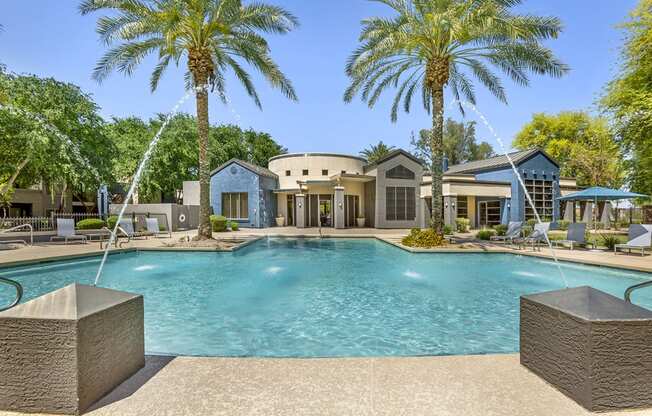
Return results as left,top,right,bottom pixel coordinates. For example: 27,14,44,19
205,149,577,228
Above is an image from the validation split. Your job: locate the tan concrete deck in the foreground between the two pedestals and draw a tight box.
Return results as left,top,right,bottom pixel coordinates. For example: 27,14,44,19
0,354,652,416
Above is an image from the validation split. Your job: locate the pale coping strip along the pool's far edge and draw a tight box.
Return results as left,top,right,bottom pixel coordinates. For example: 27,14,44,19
0,234,652,273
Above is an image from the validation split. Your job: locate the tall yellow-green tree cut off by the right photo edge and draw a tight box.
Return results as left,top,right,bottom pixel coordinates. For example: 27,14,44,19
601,0,652,195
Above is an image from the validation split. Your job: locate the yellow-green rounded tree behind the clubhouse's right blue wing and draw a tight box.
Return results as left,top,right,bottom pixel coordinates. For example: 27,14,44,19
513,111,624,188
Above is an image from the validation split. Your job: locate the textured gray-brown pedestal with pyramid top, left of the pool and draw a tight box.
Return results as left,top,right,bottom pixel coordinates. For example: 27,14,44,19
0,284,145,414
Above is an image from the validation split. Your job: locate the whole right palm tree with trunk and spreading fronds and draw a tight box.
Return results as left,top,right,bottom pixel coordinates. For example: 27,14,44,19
344,0,567,232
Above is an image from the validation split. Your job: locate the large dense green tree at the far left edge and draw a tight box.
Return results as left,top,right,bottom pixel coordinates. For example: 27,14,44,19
0,73,113,207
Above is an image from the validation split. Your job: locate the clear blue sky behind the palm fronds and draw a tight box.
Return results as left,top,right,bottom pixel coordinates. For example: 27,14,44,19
0,0,636,153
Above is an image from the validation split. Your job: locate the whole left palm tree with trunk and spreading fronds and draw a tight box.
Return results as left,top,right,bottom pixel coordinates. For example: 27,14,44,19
80,0,298,239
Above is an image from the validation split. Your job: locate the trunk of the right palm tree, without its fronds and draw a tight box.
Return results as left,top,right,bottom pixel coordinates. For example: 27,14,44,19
430,84,444,233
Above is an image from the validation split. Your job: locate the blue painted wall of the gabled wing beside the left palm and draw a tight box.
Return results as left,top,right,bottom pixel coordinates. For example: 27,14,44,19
211,162,277,228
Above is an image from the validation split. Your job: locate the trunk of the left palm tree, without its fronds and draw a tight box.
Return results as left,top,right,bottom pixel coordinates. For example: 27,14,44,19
196,82,213,240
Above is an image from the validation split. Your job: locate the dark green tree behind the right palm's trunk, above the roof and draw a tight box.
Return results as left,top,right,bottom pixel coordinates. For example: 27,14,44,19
410,118,494,165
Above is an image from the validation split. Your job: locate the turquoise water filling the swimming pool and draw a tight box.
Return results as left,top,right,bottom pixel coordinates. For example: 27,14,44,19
0,239,652,357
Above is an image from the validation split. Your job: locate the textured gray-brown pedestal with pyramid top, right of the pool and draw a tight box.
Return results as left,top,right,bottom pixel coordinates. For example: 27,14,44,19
520,286,652,411
